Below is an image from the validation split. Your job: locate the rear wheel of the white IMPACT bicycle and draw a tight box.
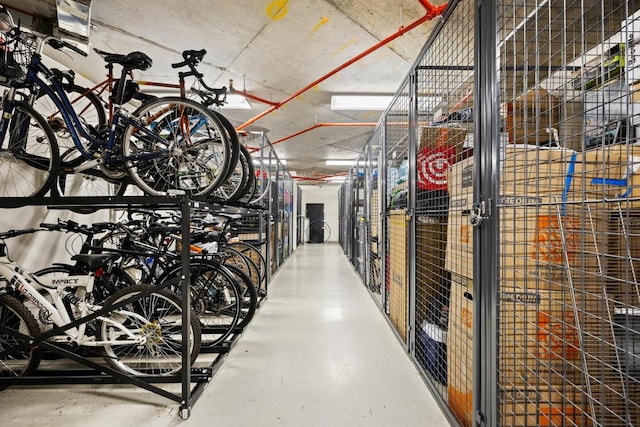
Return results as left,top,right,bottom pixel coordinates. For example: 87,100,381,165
97,285,201,376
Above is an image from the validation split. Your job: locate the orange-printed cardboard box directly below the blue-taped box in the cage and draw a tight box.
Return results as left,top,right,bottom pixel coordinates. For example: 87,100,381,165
498,288,605,387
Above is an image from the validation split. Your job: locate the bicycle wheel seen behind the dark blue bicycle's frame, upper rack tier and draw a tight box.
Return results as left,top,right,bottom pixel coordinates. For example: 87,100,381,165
33,85,107,167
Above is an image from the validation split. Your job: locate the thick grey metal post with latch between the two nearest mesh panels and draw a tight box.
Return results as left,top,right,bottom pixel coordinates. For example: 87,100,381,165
473,0,500,426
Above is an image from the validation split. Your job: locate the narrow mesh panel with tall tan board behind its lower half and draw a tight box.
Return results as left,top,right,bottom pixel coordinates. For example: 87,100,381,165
384,84,410,340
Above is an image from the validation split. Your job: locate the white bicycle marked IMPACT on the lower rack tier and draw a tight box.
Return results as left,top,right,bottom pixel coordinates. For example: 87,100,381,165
0,231,201,377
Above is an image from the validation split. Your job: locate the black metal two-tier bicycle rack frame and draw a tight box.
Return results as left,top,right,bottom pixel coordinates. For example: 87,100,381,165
0,196,264,419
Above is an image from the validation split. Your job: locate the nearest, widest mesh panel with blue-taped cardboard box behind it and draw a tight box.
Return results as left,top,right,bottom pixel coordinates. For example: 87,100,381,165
496,1,640,427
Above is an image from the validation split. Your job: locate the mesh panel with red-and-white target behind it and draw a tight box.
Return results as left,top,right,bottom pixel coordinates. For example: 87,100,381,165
414,1,474,425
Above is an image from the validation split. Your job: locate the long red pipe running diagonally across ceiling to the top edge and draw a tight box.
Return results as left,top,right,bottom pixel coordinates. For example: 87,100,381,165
236,0,449,130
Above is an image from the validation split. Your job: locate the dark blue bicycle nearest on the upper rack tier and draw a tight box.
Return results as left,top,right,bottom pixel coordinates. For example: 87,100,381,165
0,8,229,197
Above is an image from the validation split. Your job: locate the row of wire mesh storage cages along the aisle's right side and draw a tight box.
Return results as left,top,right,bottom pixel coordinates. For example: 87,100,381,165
342,0,640,427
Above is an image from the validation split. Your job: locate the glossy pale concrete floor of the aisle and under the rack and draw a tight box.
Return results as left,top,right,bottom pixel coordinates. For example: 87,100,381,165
0,244,449,427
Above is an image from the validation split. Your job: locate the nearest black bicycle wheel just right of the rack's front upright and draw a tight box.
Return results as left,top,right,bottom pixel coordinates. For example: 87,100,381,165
159,260,243,347
